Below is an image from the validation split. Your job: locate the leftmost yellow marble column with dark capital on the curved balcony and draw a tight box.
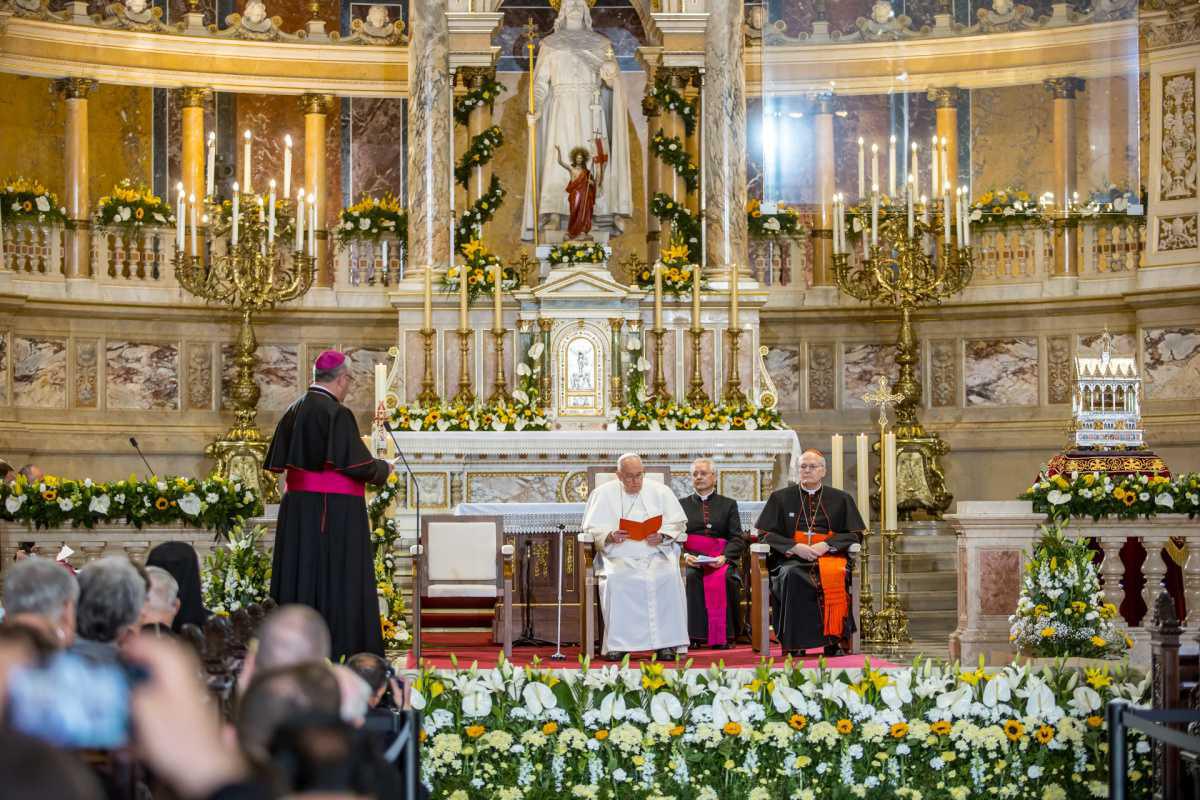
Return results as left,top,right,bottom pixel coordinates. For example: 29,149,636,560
54,78,96,278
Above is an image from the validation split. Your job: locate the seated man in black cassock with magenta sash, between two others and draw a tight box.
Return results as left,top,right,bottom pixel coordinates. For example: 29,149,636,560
679,458,746,648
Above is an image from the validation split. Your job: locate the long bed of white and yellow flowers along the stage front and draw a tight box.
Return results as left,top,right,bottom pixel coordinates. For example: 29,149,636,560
412,658,1151,800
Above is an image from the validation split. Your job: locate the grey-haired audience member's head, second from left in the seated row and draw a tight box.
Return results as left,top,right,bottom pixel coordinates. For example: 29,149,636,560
72,555,146,662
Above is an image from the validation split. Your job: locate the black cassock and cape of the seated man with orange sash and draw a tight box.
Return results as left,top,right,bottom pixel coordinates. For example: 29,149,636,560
755,485,866,650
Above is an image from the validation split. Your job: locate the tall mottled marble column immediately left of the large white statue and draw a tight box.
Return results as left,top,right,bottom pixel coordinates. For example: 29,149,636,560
408,0,451,281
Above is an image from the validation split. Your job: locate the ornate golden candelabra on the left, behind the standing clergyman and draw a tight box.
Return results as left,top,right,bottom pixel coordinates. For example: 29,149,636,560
174,194,317,498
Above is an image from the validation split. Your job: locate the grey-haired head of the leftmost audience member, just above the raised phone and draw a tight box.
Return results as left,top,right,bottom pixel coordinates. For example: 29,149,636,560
4,555,79,648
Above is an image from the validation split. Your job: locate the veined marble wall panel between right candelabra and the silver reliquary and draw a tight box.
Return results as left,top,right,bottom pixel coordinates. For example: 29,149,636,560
962,337,1038,405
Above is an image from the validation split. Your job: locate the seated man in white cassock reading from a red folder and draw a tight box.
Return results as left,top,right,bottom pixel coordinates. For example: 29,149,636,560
583,453,688,661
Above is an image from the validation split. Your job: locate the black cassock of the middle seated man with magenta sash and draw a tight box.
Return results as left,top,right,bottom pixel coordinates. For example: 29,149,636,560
679,492,746,645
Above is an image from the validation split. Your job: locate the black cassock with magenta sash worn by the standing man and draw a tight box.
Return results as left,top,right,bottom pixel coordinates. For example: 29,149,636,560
266,386,389,661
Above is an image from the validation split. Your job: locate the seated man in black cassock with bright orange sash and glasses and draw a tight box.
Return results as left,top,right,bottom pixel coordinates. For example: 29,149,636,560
755,450,866,655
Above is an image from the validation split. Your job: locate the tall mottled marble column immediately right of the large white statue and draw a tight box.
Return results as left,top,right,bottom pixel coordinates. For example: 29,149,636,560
701,0,748,279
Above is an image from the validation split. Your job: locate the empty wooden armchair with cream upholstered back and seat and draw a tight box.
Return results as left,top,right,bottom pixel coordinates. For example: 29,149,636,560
410,513,514,663
